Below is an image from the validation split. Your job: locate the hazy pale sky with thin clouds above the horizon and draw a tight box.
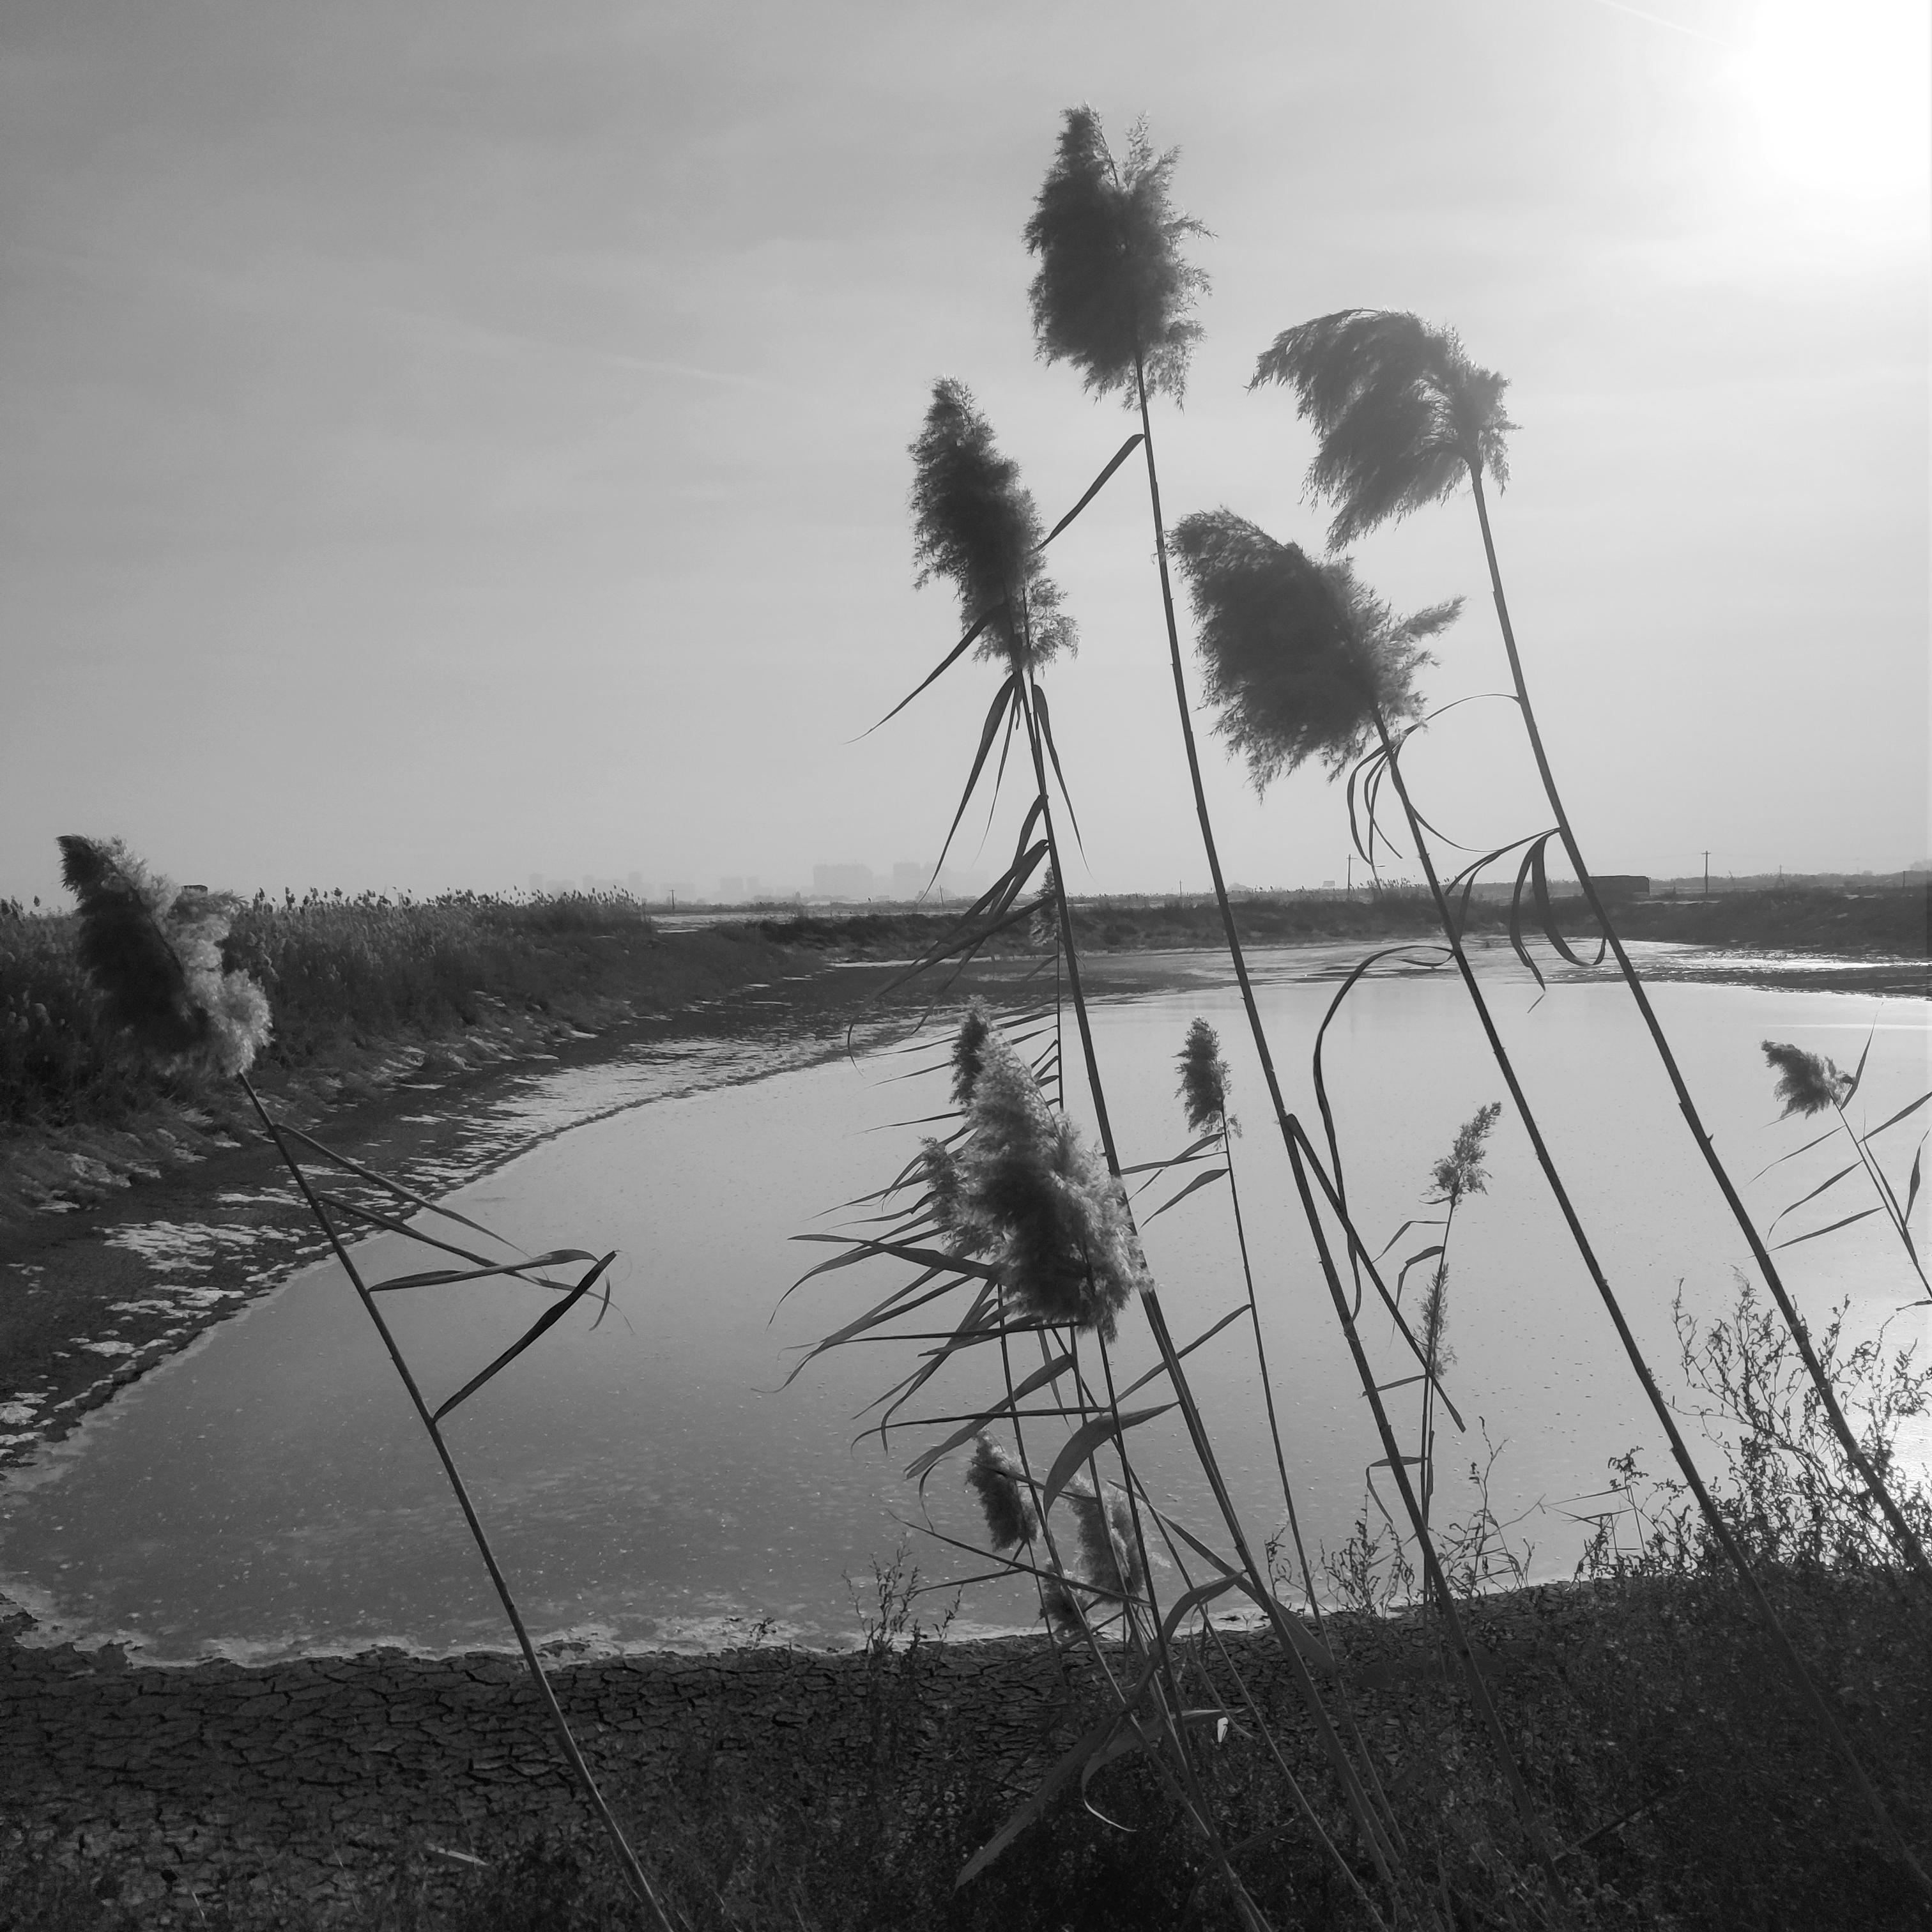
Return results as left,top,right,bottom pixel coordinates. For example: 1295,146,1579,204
0,0,1932,900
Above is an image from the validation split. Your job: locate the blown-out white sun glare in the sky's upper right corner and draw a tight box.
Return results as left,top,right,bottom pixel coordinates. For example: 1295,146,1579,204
1737,0,1932,199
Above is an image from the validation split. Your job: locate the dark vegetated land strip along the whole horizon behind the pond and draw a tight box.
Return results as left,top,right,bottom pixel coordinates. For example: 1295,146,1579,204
0,889,1928,1136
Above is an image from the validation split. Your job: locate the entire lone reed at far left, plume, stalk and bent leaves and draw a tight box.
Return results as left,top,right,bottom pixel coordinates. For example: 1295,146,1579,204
60,836,672,1932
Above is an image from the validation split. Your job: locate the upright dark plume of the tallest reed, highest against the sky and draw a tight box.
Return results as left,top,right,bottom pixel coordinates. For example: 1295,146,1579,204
1026,104,1208,408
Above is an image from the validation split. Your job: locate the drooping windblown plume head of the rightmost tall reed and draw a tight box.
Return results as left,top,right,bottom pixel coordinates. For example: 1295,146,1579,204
1248,309,1517,551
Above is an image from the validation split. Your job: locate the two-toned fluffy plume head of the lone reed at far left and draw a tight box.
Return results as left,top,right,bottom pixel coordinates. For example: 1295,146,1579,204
60,834,270,1074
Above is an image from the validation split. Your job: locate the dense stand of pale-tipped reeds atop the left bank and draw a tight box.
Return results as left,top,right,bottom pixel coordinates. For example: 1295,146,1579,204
0,891,655,1126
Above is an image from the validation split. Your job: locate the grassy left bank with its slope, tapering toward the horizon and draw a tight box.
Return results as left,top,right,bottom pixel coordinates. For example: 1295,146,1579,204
0,893,809,1213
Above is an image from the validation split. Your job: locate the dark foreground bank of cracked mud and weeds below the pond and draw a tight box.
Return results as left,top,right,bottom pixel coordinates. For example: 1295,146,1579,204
0,1575,1932,1932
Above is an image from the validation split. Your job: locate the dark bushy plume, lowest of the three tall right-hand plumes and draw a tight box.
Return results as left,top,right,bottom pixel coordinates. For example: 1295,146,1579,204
1169,510,1462,792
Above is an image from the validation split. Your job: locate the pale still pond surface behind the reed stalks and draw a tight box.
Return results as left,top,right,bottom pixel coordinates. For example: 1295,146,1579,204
0,951,1932,1660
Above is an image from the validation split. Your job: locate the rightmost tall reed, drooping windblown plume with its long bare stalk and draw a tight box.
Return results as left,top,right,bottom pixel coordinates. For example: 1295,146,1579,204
1250,309,1932,1584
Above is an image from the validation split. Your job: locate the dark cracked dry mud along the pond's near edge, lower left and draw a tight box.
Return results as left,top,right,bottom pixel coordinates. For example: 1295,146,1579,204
0,1623,1062,1924
